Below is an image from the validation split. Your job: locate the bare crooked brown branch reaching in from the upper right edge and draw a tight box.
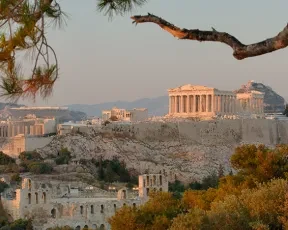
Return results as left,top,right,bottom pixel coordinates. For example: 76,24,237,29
131,13,288,60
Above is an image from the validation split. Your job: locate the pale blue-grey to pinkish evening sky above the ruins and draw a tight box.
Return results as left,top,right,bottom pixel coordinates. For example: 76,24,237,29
14,0,288,106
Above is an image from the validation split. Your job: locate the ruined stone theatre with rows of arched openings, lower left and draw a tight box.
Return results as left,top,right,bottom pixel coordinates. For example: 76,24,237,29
0,174,168,230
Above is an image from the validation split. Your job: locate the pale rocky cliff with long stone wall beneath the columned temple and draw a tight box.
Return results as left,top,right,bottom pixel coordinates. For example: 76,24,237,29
38,119,288,182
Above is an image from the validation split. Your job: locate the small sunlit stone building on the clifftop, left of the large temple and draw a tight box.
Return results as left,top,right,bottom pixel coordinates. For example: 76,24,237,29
102,107,148,122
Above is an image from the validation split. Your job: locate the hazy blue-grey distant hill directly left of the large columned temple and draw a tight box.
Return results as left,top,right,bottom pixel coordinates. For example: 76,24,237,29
64,96,169,117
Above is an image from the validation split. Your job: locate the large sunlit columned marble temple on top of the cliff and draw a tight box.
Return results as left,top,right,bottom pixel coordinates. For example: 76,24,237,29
168,84,264,117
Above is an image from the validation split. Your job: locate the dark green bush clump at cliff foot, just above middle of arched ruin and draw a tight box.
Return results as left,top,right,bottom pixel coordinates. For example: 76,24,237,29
92,158,137,184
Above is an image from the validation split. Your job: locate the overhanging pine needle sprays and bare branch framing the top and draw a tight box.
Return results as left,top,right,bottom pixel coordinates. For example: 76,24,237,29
0,0,288,99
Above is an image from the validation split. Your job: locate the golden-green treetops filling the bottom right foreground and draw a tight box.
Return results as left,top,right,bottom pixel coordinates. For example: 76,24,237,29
109,145,288,230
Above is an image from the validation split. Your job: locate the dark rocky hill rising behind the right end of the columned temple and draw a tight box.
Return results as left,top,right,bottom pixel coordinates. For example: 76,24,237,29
235,81,285,113
